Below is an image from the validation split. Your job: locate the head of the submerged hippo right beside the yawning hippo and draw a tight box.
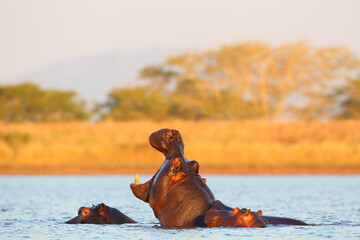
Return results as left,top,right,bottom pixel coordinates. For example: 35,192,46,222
205,208,268,227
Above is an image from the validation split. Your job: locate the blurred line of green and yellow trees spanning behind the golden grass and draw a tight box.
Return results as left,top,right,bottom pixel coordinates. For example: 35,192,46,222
0,42,360,122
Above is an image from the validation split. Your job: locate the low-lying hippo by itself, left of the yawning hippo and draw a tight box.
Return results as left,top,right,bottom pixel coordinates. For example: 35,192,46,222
66,203,136,224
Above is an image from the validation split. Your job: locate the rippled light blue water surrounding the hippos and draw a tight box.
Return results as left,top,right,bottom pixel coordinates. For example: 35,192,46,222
0,175,360,239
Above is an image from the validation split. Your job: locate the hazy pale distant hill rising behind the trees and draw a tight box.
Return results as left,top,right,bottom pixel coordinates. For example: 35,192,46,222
1,48,190,102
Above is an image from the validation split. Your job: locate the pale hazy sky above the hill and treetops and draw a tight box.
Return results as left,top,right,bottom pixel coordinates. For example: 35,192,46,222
0,0,360,80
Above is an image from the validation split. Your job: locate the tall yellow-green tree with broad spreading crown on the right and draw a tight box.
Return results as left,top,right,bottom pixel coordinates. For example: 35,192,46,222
140,42,359,120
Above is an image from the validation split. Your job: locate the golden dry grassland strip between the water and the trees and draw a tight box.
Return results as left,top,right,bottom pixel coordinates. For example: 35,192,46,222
0,121,360,174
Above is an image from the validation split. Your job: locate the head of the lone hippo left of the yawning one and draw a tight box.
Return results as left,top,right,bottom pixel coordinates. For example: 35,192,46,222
66,203,111,224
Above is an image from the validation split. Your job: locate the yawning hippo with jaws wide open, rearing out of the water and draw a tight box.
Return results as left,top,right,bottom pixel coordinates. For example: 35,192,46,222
130,129,305,228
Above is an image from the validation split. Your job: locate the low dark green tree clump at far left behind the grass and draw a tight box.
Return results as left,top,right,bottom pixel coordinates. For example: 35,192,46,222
0,83,90,122
